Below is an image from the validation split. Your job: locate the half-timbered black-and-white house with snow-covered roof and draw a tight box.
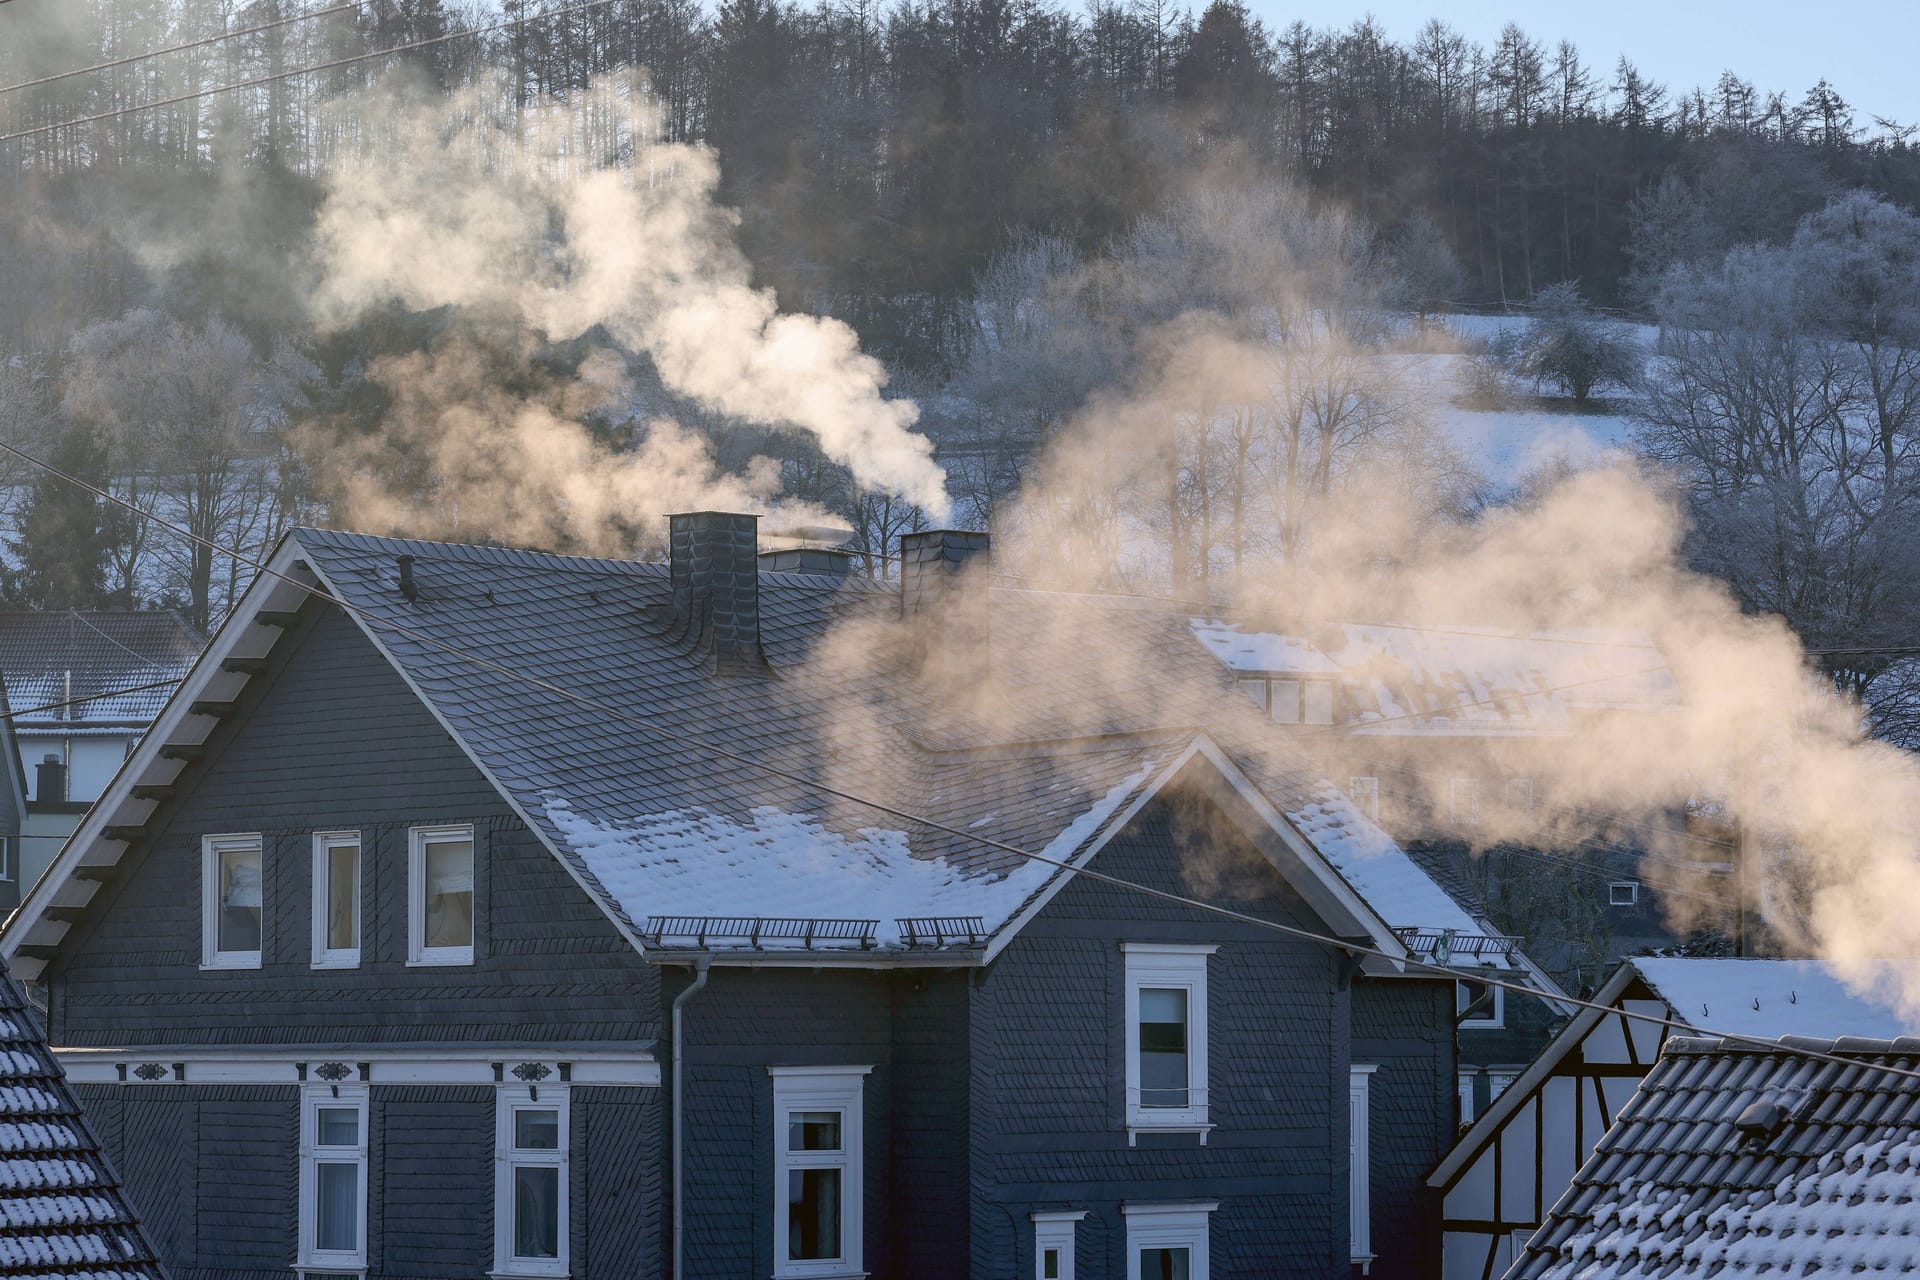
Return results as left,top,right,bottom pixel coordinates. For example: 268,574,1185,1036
1428,958,1907,1280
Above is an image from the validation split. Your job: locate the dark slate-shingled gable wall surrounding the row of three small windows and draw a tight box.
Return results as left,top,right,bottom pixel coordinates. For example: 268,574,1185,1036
48,612,659,1046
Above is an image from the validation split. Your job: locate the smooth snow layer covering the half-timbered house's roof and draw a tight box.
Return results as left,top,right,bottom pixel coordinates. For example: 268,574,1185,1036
1628,956,1920,1040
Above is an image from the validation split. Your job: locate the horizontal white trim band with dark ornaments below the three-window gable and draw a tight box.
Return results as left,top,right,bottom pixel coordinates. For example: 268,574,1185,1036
54,1044,660,1088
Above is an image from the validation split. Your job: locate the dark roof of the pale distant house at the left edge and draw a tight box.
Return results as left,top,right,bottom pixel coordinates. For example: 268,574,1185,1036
0,610,205,731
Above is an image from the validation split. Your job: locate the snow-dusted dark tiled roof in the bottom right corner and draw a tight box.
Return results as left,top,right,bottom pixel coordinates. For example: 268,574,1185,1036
1507,1036,1920,1280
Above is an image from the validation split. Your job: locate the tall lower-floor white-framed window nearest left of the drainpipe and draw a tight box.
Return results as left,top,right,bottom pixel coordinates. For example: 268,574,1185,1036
493,1084,570,1276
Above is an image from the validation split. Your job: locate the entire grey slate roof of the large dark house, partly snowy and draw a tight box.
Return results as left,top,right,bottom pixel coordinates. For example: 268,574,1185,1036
292,530,1476,944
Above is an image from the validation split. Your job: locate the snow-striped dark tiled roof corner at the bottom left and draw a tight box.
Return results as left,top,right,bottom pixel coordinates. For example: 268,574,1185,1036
0,967,165,1280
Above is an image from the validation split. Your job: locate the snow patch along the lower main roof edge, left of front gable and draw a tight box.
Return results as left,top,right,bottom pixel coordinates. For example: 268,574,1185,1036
545,758,1160,946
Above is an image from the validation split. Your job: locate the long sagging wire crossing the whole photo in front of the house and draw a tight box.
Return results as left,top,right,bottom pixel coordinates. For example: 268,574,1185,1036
0,441,1920,1080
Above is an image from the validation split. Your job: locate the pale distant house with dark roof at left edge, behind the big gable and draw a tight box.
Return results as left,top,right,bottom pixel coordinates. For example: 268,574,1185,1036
0,610,205,885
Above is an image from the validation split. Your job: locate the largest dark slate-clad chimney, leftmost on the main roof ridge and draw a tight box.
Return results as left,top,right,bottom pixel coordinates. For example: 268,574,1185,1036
666,510,766,676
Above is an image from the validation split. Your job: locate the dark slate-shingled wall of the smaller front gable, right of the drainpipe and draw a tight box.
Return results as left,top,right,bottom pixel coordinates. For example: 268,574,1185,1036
972,802,1348,1280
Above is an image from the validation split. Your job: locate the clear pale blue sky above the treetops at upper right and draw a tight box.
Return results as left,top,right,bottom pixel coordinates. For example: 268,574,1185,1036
1244,0,1920,127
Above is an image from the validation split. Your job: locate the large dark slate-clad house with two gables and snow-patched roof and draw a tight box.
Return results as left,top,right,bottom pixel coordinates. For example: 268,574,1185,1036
0,512,1511,1280
